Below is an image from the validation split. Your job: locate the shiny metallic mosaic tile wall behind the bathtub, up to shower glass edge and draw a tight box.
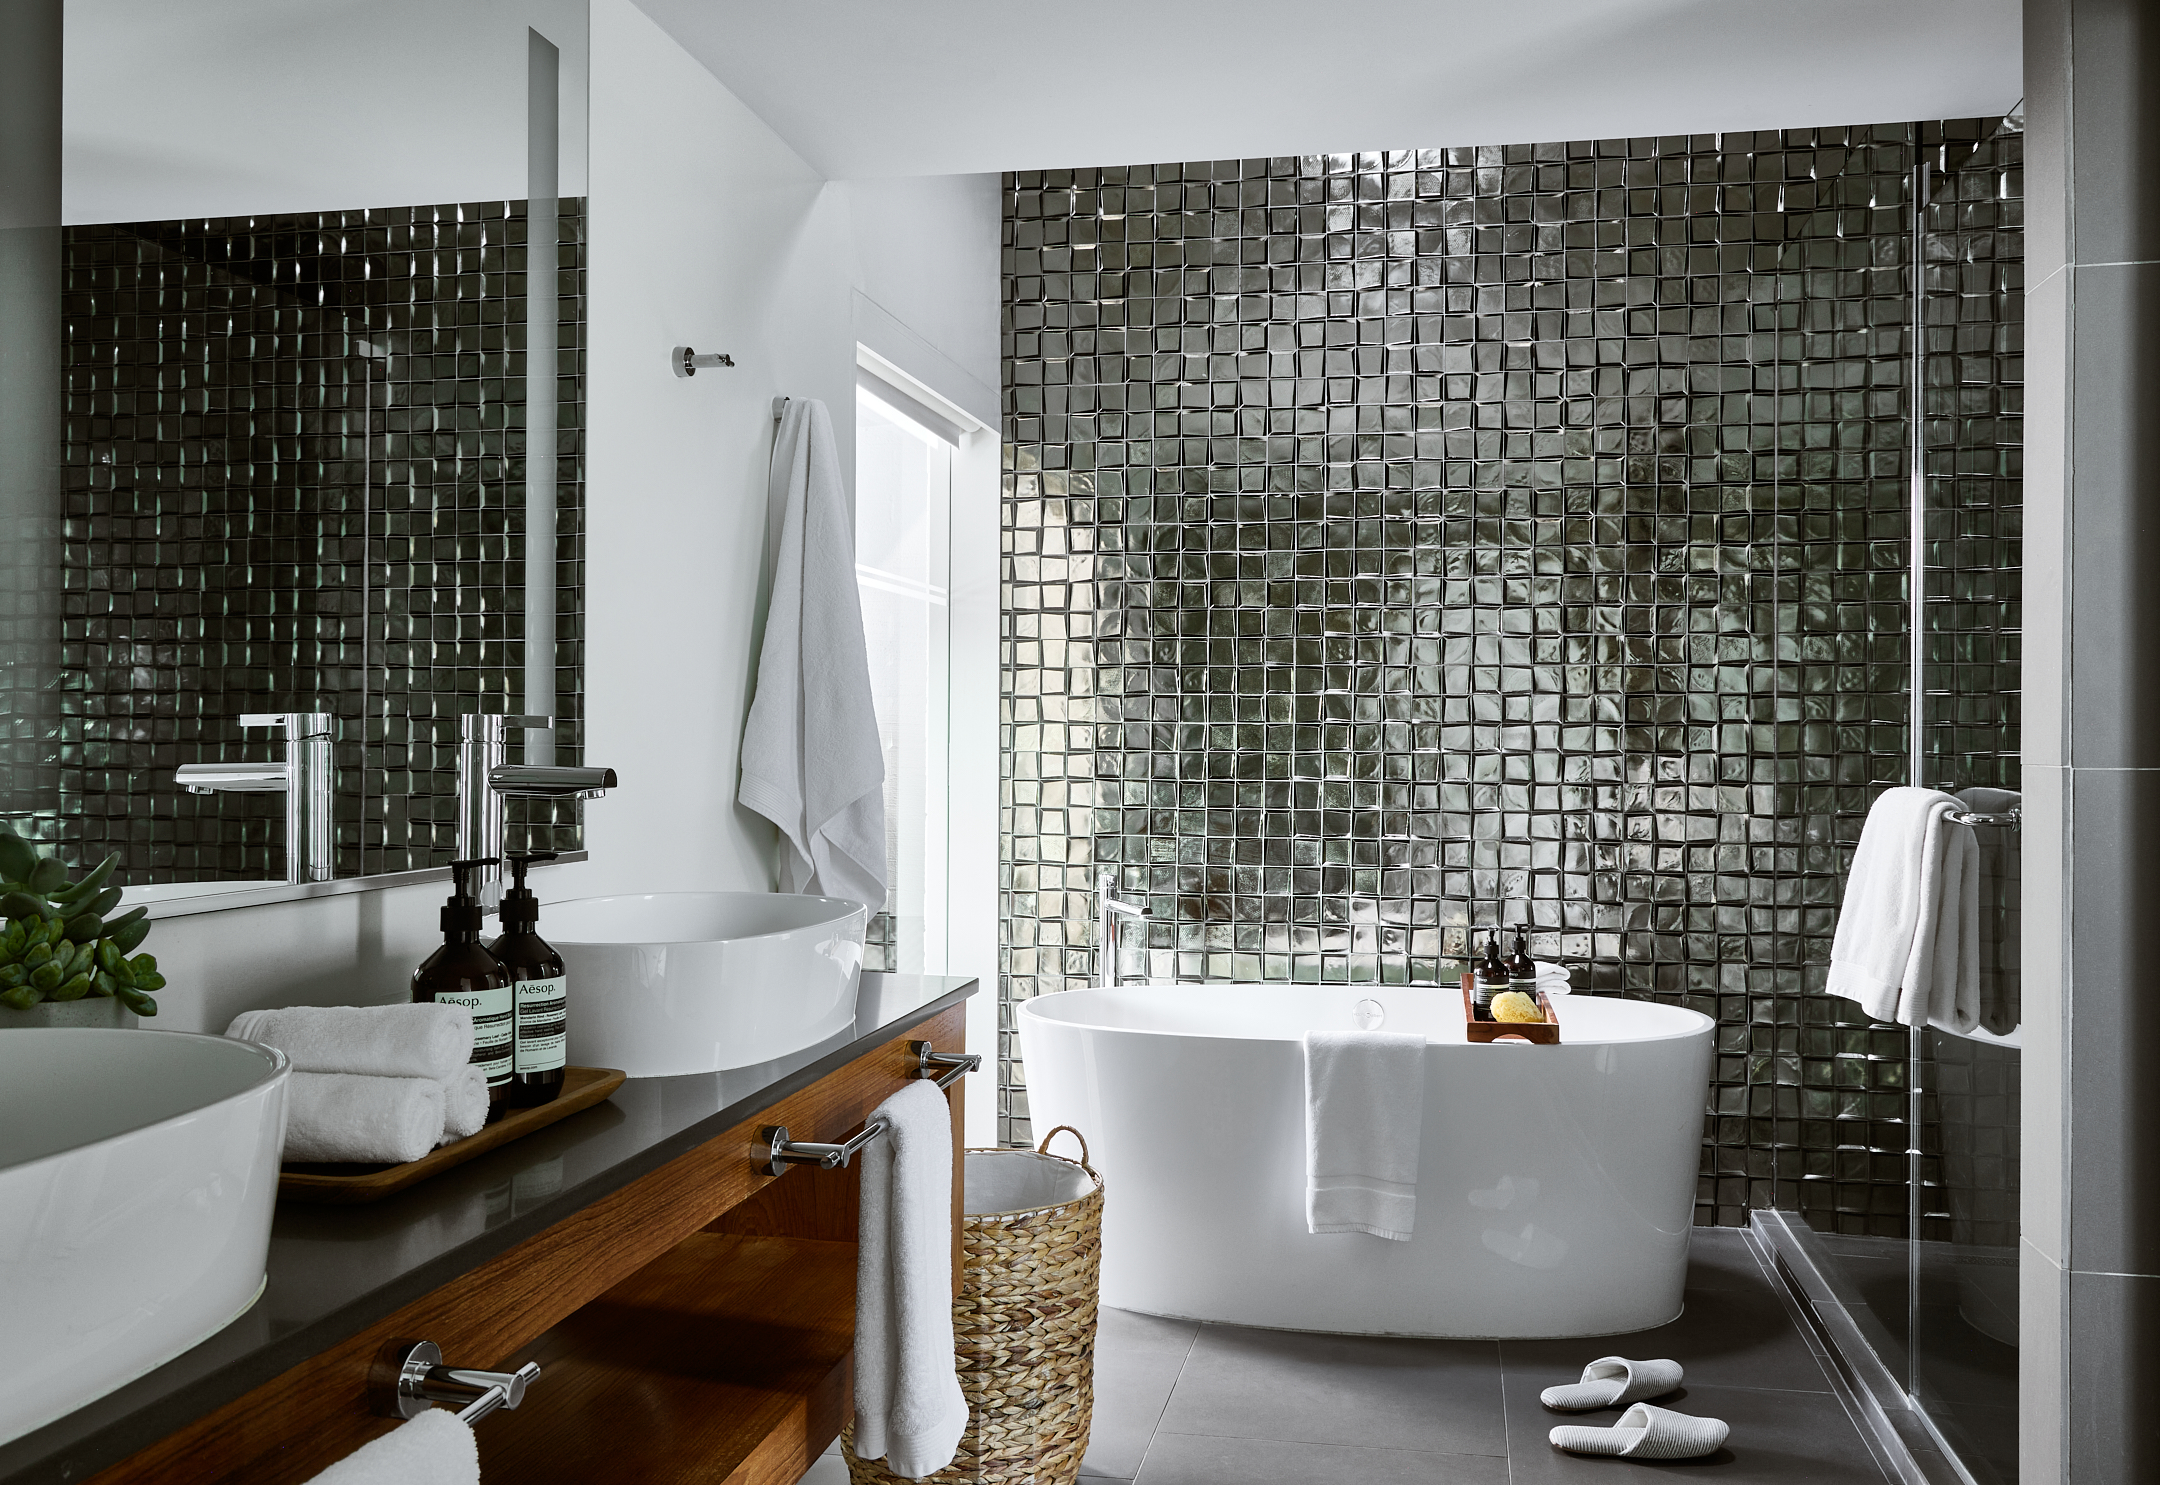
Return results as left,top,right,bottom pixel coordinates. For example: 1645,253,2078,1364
1000,121,1994,1235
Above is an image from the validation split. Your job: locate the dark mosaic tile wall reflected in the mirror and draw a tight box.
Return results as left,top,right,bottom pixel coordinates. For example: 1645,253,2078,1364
37,201,585,883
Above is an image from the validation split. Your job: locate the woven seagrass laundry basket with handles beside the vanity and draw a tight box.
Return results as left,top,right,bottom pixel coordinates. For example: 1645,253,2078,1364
840,1125,1102,1485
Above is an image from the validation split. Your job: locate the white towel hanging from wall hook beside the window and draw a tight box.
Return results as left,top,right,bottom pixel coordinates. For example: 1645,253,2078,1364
737,397,886,913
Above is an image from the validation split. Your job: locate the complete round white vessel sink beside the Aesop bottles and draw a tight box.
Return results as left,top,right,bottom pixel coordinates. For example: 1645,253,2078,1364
540,891,870,1077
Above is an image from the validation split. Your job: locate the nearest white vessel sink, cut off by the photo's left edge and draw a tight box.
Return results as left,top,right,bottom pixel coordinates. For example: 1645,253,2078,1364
0,1027,287,1442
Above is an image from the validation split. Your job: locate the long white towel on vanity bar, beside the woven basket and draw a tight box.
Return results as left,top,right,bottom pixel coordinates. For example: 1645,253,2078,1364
855,1081,968,1481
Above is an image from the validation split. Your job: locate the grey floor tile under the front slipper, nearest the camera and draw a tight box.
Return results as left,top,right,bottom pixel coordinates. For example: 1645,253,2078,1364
1508,1377,1884,1485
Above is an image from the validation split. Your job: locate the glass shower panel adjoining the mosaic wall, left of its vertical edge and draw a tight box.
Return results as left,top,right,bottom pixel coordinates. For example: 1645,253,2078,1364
1773,130,1916,1371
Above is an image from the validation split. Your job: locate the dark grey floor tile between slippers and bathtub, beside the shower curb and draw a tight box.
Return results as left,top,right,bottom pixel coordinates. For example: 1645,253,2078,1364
1499,1284,1830,1401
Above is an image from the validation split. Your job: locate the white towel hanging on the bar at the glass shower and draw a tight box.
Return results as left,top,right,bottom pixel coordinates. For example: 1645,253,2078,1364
1825,788,1981,1032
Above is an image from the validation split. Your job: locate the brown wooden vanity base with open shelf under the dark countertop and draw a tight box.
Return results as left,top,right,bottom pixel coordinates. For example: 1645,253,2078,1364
73,1002,966,1485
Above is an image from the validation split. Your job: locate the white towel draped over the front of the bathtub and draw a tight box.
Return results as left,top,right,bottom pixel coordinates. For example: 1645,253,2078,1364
1305,1032,1426,1243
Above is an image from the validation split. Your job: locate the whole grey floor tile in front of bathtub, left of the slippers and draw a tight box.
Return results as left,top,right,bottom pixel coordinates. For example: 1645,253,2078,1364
1143,1325,1508,1476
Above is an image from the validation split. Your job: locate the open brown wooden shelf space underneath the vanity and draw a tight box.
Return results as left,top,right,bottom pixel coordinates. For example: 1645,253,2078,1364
475,1225,855,1485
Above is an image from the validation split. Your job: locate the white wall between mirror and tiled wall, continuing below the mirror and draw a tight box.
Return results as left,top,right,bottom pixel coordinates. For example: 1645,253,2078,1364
149,0,998,1096
